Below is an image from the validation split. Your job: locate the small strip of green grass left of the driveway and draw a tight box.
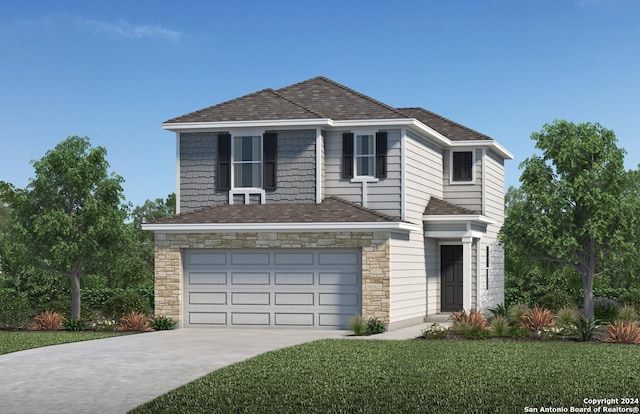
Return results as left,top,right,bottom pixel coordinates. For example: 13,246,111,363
0,331,122,355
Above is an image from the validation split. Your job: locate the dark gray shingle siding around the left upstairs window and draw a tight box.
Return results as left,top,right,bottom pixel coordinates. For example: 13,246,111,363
180,130,316,213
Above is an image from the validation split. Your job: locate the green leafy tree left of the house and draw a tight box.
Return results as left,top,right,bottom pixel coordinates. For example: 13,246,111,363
3,136,127,318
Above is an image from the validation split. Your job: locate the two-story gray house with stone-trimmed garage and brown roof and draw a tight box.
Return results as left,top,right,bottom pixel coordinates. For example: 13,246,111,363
144,77,513,329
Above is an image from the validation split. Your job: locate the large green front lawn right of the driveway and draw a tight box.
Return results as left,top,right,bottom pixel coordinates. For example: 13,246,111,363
132,340,640,414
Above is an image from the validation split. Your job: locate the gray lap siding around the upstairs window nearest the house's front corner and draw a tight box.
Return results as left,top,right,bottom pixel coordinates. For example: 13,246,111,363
325,130,401,217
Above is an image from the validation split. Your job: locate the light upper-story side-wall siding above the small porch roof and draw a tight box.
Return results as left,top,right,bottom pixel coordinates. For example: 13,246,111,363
404,132,443,223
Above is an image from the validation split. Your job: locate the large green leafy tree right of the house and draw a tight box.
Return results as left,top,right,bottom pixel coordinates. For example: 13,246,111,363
501,120,637,317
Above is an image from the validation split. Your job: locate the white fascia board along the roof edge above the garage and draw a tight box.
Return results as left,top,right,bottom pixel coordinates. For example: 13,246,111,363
142,222,421,233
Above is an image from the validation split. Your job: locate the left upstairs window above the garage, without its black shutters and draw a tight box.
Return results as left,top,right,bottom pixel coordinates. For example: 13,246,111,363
233,136,262,188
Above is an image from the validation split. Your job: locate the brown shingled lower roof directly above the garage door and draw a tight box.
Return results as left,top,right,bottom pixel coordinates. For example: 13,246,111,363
149,197,399,224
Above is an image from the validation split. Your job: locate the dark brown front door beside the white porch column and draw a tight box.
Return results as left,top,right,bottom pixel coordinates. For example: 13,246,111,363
440,246,463,312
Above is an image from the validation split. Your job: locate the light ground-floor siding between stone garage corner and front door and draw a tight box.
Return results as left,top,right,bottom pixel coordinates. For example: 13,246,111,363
389,231,427,323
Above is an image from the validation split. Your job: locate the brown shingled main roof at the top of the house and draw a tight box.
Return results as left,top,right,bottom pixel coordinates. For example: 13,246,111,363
165,76,491,141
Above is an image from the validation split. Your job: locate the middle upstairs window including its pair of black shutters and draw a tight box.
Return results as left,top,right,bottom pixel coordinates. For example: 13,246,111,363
342,131,387,178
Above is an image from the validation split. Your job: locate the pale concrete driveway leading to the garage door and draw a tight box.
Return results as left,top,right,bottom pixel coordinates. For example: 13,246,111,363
0,329,347,414
